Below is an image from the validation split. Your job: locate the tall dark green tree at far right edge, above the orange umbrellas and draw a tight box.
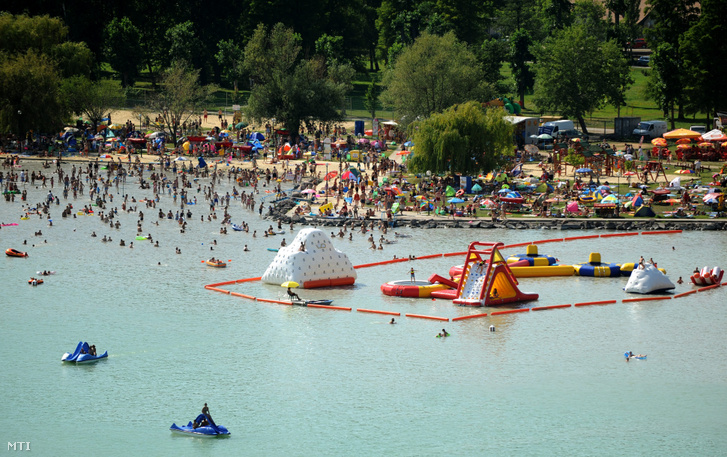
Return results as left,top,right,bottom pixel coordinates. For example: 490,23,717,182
679,0,727,125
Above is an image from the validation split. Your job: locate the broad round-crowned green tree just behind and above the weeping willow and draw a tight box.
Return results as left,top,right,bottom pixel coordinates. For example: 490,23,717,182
381,32,494,125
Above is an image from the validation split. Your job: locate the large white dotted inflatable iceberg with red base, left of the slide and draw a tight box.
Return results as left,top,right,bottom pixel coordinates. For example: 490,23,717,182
262,228,356,289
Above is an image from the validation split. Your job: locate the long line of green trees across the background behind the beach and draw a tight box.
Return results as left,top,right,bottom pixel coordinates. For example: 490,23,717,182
0,0,727,150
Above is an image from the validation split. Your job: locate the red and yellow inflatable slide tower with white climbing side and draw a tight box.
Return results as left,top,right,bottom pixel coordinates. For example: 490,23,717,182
454,241,538,306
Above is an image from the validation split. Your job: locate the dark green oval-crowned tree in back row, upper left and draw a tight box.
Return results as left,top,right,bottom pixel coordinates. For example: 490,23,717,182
104,17,143,87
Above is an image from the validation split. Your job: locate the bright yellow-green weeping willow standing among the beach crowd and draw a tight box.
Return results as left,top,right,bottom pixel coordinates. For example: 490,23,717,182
410,101,514,174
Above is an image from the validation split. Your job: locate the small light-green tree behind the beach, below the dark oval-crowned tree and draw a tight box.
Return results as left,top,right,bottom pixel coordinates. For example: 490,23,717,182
61,76,124,132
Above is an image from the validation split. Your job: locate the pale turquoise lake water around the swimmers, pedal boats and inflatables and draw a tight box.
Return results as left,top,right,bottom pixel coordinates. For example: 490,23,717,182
0,165,727,456
